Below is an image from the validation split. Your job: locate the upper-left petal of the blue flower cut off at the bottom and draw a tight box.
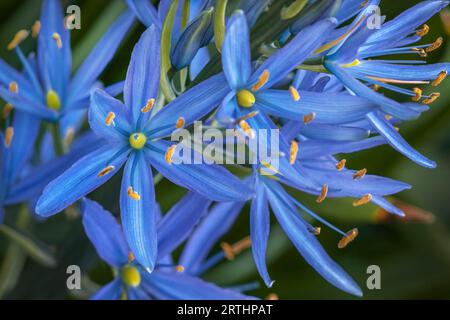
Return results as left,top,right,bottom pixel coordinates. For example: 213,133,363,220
81,198,128,267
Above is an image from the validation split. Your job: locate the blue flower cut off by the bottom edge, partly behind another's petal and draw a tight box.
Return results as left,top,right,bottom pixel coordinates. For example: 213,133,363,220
82,198,253,300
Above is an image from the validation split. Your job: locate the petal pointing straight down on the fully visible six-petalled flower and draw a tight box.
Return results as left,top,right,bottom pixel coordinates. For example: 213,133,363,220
120,152,158,272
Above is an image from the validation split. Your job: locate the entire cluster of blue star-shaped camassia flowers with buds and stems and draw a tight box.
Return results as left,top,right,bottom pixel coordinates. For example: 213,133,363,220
0,0,450,299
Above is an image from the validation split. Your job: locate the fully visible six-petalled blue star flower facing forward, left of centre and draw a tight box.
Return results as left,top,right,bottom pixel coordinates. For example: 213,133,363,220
36,26,252,271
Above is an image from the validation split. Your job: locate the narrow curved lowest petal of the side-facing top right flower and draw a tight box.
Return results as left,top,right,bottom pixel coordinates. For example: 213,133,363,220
367,112,436,168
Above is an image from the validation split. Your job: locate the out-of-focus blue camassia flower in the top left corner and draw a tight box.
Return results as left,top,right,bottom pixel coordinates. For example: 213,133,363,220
0,0,134,136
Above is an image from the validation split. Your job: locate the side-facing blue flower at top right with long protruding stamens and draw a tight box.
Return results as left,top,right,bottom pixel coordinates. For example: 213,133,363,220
324,0,450,168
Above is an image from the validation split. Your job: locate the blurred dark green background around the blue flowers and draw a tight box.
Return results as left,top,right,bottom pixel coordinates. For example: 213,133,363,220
0,0,450,299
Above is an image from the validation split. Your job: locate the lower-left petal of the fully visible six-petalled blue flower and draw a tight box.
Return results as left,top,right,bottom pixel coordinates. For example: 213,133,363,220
35,145,129,217
